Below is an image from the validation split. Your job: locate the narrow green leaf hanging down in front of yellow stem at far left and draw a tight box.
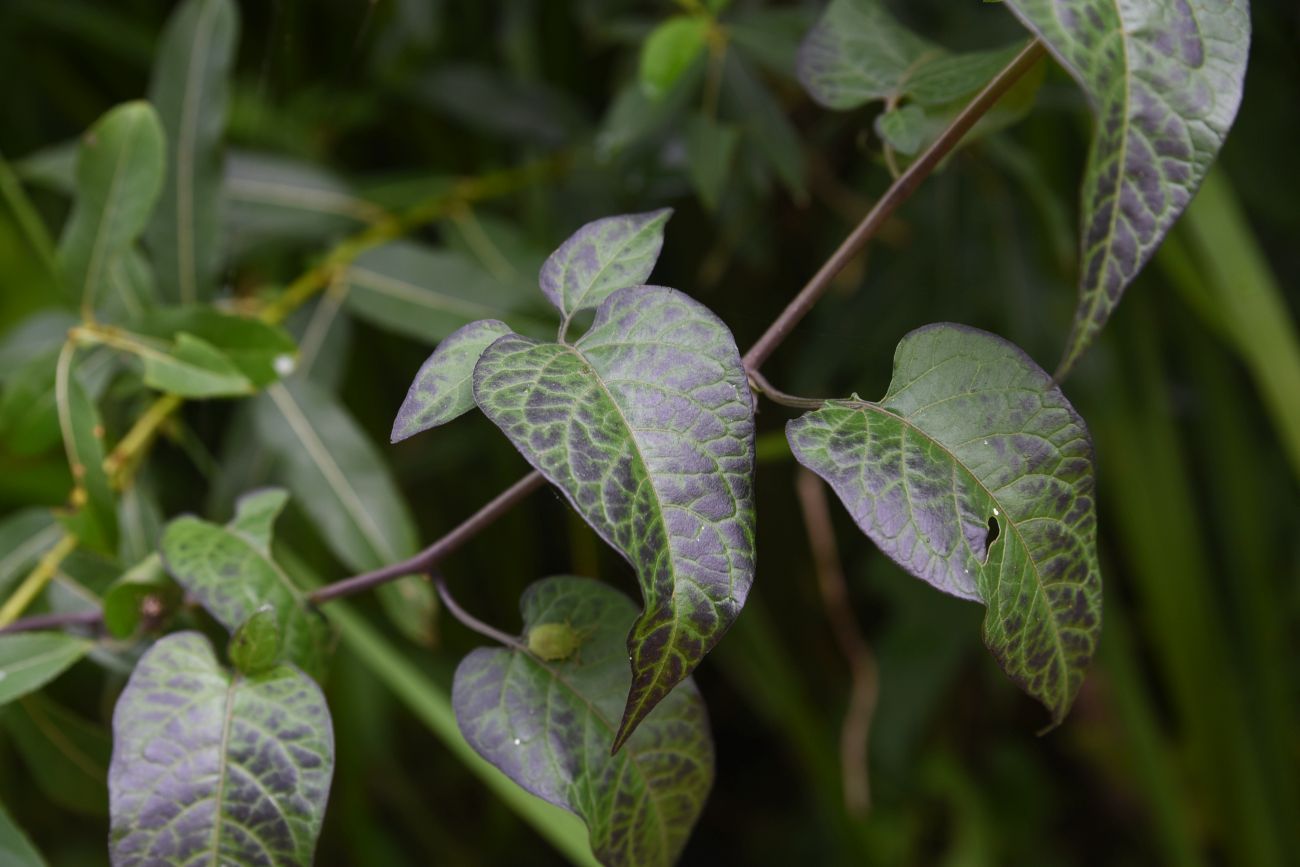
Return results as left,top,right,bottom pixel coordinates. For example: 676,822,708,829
55,353,117,556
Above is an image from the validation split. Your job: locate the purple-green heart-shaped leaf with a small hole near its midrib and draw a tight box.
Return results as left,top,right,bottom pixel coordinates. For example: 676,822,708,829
787,324,1101,724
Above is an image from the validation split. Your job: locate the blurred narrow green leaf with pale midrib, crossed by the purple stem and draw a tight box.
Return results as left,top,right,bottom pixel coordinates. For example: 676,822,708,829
254,378,437,643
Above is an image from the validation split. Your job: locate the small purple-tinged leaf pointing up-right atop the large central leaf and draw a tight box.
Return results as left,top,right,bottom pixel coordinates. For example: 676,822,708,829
540,208,672,330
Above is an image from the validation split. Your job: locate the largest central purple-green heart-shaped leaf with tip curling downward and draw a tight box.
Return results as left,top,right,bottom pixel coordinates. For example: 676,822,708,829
475,286,754,749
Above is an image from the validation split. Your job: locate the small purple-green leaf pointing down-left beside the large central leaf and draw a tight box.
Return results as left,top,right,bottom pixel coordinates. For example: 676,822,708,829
391,320,511,442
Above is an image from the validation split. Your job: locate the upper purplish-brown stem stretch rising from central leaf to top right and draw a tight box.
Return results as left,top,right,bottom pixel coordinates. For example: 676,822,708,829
744,39,1045,372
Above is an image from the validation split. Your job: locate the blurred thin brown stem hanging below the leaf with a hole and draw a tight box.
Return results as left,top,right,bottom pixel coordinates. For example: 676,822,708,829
796,467,879,816
